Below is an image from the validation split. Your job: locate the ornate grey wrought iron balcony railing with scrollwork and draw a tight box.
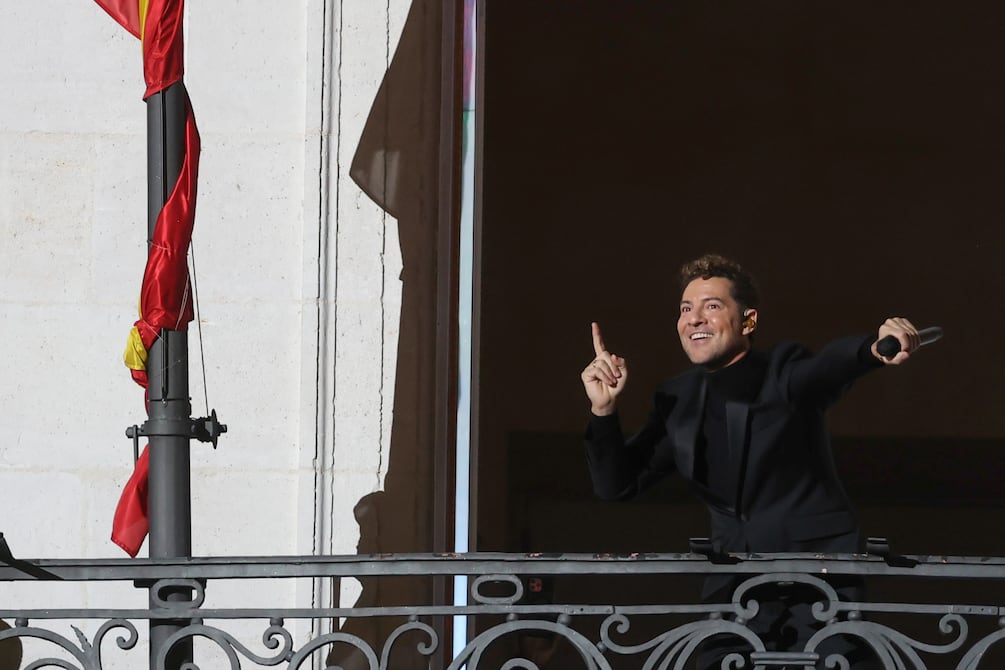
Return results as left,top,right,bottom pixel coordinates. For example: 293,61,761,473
0,551,1005,670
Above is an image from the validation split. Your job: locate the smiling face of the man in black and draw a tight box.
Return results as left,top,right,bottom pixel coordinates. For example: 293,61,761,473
677,277,757,370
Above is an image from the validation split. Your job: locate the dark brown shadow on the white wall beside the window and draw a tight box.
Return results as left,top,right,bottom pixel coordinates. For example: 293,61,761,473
328,0,441,670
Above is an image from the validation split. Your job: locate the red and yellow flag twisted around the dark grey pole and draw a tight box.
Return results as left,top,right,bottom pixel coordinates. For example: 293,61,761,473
95,0,200,556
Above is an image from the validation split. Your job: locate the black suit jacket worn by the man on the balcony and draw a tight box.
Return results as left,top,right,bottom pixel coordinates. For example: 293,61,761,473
586,337,881,552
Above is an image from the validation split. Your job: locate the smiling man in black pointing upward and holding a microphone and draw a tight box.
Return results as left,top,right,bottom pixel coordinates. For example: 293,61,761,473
581,254,920,670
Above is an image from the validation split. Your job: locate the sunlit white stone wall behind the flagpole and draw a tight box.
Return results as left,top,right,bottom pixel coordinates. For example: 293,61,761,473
0,0,408,667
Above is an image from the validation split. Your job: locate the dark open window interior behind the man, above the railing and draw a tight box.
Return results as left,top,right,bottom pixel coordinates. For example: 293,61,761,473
475,0,1005,570
